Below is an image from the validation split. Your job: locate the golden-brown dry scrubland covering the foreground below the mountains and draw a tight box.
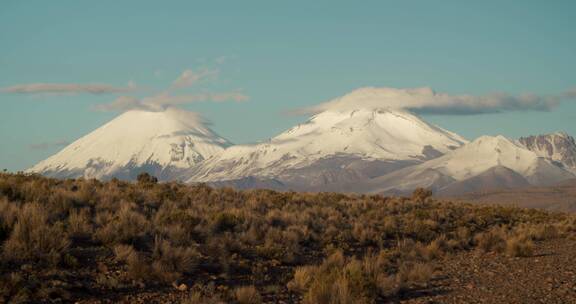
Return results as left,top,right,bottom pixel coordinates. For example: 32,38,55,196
0,173,576,304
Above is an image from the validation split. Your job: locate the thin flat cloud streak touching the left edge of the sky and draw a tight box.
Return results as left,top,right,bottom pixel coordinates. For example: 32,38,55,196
0,81,136,94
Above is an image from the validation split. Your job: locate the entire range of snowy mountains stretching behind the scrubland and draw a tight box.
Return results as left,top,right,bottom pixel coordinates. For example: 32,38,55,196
28,89,576,195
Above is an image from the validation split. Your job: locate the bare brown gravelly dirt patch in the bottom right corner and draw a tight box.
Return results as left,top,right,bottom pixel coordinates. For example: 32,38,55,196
401,239,576,303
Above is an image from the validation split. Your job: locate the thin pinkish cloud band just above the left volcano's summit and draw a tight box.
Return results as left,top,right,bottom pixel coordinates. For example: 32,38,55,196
94,92,249,111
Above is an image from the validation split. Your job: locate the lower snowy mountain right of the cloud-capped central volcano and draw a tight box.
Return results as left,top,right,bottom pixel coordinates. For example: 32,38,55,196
359,136,574,192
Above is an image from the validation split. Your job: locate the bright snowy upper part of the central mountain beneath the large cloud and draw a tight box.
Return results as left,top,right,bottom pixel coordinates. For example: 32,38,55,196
270,108,466,159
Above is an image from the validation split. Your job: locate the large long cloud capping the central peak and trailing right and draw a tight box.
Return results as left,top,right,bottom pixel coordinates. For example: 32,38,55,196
294,87,562,114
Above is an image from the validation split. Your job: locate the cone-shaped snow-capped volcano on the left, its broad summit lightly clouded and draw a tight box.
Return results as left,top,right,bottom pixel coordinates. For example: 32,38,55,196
28,108,230,179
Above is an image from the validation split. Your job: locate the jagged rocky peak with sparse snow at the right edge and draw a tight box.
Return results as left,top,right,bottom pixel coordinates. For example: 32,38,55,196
519,132,576,173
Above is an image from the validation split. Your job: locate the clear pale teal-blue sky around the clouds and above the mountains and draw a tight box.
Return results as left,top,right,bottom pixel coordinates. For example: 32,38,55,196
0,0,576,170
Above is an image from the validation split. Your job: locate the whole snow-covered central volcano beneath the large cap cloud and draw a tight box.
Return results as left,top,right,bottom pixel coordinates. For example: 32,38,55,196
188,105,466,184
